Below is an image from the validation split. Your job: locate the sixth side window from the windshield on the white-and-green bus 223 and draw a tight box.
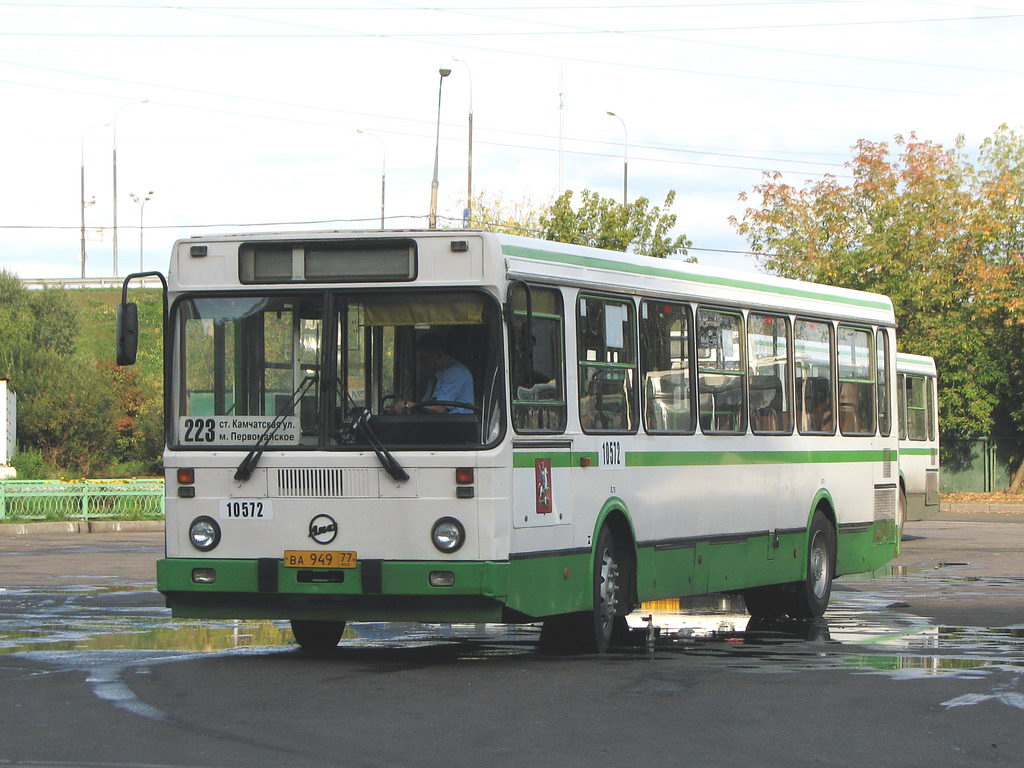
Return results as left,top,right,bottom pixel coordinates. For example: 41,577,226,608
794,319,836,434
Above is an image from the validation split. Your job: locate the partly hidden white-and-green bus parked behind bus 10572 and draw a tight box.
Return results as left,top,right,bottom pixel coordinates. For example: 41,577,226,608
896,352,939,520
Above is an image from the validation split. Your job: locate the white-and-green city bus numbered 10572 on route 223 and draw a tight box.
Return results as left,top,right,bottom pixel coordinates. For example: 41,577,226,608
118,230,900,652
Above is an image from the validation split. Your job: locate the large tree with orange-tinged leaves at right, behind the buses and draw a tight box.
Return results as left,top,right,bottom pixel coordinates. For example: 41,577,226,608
732,129,1024,450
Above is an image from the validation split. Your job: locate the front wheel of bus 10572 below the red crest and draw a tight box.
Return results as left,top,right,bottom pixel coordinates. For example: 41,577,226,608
540,526,629,653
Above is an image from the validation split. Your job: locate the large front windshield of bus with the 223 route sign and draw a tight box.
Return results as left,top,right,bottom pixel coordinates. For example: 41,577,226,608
171,291,504,450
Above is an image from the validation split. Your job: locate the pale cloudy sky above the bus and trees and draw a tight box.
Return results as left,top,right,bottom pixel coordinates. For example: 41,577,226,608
0,0,1024,279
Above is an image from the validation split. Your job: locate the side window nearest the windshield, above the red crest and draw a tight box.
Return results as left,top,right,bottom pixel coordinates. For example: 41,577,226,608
509,285,566,432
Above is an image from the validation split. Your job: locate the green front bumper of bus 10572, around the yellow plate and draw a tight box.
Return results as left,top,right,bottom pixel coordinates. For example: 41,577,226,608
157,558,516,623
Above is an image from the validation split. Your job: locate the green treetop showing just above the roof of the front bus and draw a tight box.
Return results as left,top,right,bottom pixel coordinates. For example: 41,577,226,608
540,189,693,261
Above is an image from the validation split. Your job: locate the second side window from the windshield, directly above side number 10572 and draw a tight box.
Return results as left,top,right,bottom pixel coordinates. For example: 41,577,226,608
577,295,637,432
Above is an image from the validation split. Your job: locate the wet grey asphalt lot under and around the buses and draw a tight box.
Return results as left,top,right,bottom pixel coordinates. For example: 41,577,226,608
0,516,1024,768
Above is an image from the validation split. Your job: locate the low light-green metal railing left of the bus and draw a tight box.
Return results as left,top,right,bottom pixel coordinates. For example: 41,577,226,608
0,477,164,521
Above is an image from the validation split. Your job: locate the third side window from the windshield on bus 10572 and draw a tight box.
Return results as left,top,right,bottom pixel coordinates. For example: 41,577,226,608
640,300,694,434
